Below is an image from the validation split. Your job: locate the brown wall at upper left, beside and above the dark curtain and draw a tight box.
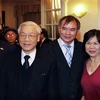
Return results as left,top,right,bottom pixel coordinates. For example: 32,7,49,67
0,0,40,29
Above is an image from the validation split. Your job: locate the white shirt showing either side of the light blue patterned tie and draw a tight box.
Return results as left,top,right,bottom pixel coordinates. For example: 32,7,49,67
57,38,74,61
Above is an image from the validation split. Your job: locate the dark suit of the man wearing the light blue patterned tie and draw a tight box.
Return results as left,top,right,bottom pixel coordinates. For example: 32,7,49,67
49,39,84,100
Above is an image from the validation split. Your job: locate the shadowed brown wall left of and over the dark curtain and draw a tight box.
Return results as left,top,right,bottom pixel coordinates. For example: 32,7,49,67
2,0,39,28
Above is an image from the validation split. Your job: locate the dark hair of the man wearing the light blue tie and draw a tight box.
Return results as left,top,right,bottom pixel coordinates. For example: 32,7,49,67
58,15,80,30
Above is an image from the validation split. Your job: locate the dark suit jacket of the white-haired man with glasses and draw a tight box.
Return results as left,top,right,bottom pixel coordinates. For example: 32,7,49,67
0,47,58,100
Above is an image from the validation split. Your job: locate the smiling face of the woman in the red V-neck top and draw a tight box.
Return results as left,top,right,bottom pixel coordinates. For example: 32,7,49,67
85,36,100,57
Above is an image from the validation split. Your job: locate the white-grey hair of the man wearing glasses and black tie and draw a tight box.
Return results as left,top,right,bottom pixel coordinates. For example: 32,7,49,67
18,21,42,34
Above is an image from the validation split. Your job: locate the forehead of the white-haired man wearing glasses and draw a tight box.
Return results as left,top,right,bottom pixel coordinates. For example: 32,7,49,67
20,25,37,33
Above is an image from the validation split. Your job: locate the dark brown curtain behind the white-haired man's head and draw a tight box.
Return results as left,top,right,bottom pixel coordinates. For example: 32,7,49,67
15,4,41,27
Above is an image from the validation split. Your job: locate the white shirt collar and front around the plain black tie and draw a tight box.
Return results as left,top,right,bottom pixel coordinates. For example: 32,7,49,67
21,49,36,66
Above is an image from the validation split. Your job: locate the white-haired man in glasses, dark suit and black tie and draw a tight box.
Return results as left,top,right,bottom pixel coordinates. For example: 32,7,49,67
0,21,57,100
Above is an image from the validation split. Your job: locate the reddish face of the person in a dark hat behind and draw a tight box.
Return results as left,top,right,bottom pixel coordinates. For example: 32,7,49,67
5,31,17,44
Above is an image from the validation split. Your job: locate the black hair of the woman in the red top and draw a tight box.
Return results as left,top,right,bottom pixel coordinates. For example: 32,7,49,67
83,29,100,58
